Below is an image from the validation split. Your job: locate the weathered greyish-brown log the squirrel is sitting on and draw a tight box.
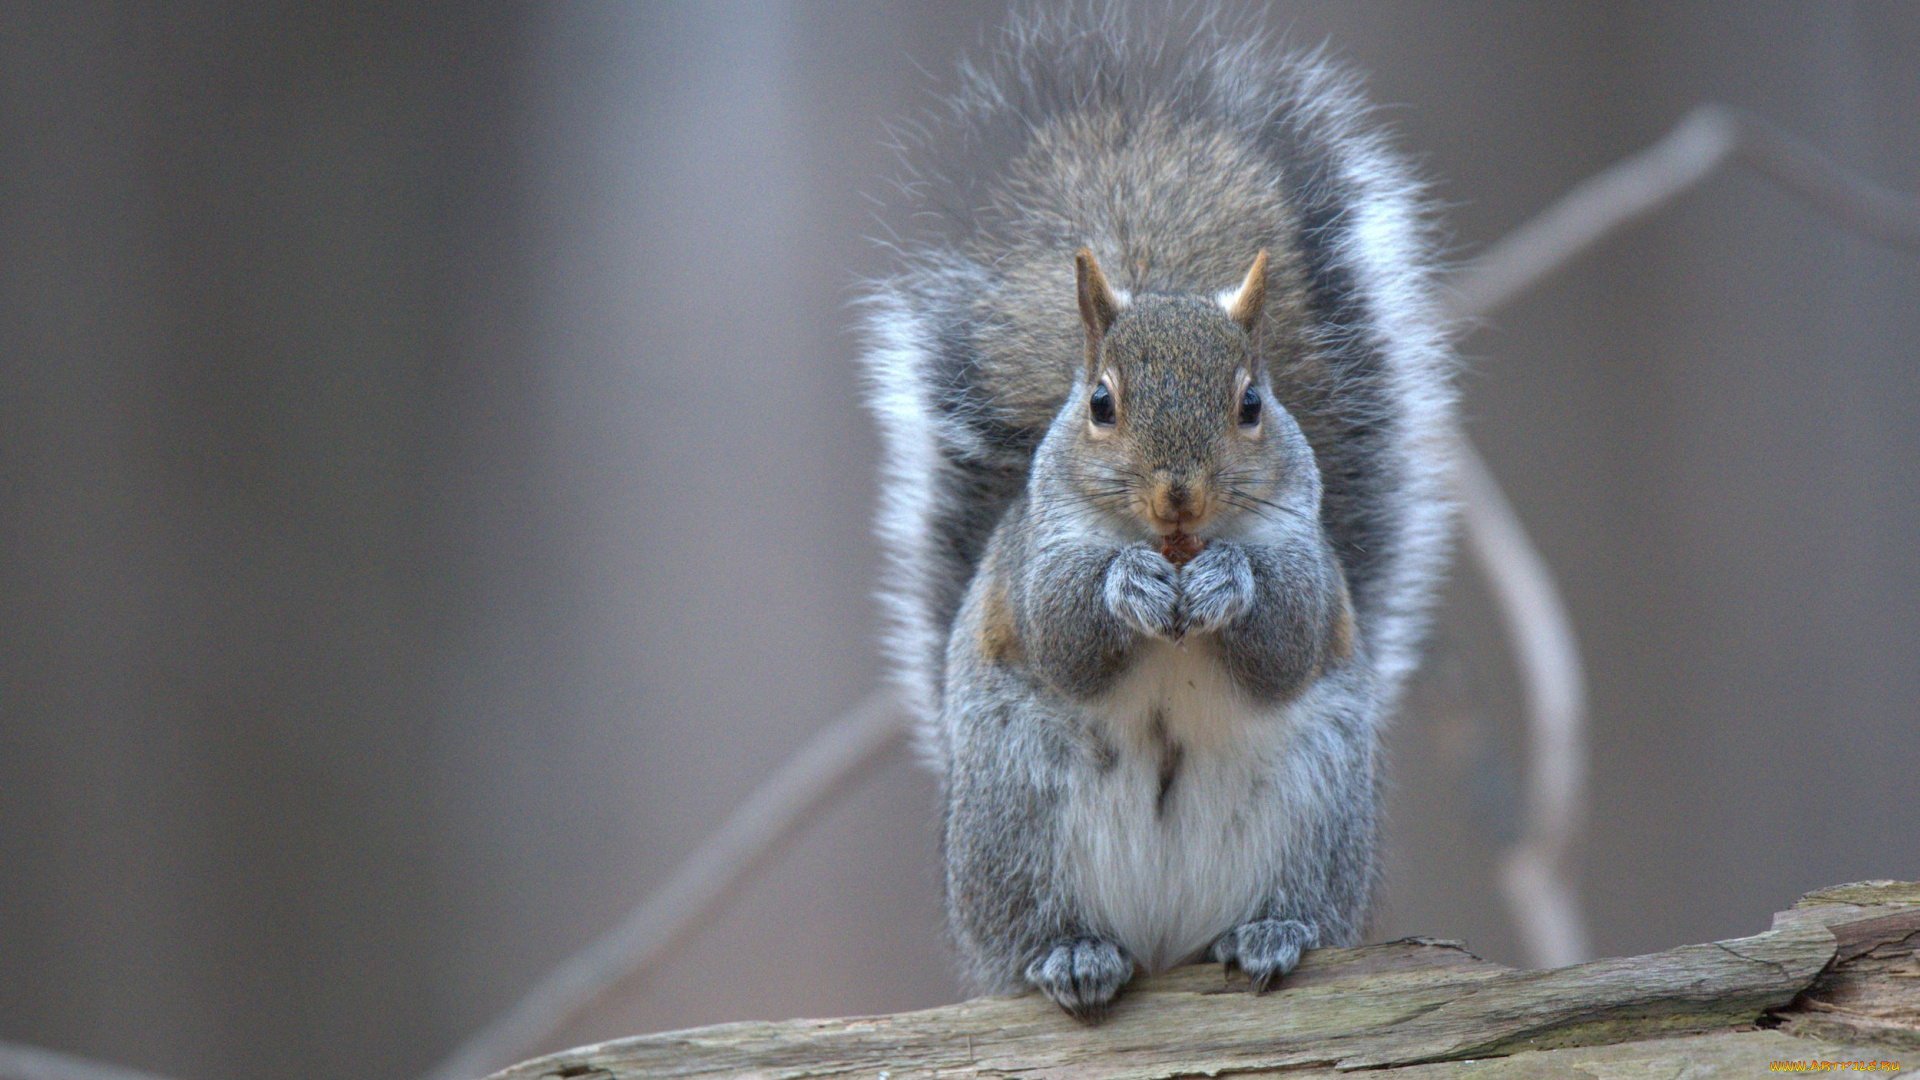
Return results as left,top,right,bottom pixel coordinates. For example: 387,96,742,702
497,882,1920,1080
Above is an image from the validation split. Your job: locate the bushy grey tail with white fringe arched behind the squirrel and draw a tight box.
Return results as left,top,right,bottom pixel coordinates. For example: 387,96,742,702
864,4,1452,774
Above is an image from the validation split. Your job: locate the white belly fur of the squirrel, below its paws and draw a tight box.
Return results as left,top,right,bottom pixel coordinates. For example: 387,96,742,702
1062,640,1292,970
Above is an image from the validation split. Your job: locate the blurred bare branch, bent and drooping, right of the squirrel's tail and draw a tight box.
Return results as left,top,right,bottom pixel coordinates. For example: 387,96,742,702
1448,106,1920,967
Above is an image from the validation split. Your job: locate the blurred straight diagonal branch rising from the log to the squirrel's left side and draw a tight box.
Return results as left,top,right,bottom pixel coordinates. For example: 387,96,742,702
416,692,906,1080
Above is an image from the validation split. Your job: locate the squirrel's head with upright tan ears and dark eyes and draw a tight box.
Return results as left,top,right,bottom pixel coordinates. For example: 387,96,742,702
1056,248,1311,536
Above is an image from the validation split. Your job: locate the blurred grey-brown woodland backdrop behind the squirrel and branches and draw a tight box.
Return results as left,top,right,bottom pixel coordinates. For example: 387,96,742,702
0,0,1920,1080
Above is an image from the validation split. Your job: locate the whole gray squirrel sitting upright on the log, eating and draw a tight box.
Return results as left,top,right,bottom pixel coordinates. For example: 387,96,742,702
866,8,1452,1020
